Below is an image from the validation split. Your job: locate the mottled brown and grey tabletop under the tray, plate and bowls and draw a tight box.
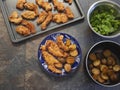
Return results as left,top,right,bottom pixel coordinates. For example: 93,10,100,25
0,0,120,90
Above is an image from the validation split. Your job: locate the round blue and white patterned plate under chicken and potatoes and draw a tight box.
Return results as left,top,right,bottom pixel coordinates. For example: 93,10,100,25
38,33,82,76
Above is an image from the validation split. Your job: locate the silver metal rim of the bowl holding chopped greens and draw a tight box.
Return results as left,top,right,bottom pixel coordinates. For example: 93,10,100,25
87,0,120,38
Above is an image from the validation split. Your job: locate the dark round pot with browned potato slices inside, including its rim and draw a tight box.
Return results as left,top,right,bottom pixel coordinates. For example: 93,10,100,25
85,40,120,87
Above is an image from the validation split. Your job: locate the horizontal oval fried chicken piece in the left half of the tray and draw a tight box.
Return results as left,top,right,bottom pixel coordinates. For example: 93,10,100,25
21,10,36,20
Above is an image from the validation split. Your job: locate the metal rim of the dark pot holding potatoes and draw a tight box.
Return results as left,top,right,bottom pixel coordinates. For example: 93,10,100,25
85,40,120,87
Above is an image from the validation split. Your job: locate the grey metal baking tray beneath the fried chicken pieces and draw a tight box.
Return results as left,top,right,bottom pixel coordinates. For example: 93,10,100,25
0,0,84,43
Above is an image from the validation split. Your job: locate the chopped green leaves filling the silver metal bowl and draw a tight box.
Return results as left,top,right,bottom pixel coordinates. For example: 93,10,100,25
90,6,120,35
